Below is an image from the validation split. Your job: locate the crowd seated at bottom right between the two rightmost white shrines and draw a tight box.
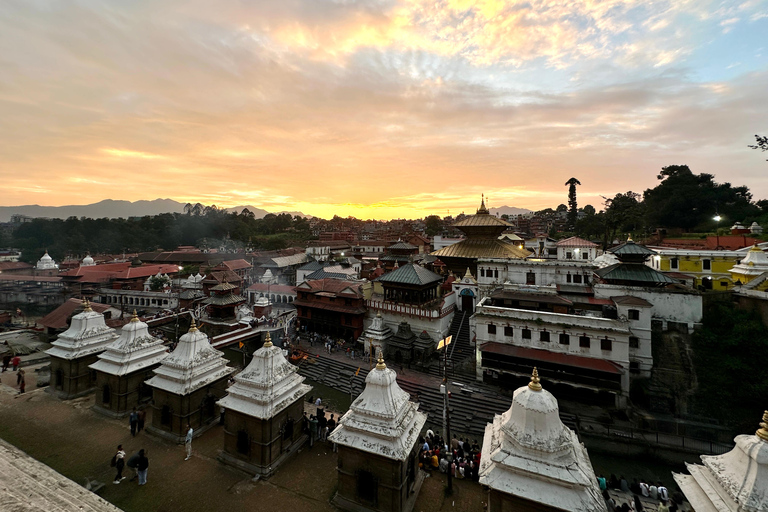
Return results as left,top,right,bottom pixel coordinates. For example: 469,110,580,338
597,475,683,512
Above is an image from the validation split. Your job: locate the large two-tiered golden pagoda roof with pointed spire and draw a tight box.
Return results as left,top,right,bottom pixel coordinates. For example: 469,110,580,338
432,199,531,275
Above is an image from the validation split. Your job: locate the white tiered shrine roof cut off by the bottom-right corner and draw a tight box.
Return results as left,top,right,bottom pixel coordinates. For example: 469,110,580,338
672,411,768,512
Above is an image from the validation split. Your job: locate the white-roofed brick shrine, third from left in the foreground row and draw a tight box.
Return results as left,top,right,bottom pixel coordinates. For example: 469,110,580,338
147,318,235,442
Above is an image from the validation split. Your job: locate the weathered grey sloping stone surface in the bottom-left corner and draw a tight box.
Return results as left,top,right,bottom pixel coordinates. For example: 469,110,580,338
0,439,120,512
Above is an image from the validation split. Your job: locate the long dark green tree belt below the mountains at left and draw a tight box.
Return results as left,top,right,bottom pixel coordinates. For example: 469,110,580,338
9,205,310,262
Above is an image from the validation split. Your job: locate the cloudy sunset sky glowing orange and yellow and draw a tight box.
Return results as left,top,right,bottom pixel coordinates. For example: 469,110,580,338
0,0,768,219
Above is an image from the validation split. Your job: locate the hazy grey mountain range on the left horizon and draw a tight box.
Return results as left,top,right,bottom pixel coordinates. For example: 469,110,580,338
0,199,309,222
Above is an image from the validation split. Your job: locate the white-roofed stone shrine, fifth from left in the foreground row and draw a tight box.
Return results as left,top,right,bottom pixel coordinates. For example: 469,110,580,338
328,354,427,512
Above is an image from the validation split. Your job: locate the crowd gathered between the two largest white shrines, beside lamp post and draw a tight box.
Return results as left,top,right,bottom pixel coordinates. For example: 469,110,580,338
419,429,480,482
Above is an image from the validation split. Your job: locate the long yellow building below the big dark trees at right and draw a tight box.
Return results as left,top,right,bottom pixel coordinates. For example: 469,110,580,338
646,247,745,290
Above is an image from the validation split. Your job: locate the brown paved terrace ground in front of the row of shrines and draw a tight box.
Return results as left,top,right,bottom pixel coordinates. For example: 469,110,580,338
0,367,486,512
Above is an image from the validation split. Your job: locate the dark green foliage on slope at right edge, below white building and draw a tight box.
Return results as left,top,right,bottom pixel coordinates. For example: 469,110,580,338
693,302,768,432
